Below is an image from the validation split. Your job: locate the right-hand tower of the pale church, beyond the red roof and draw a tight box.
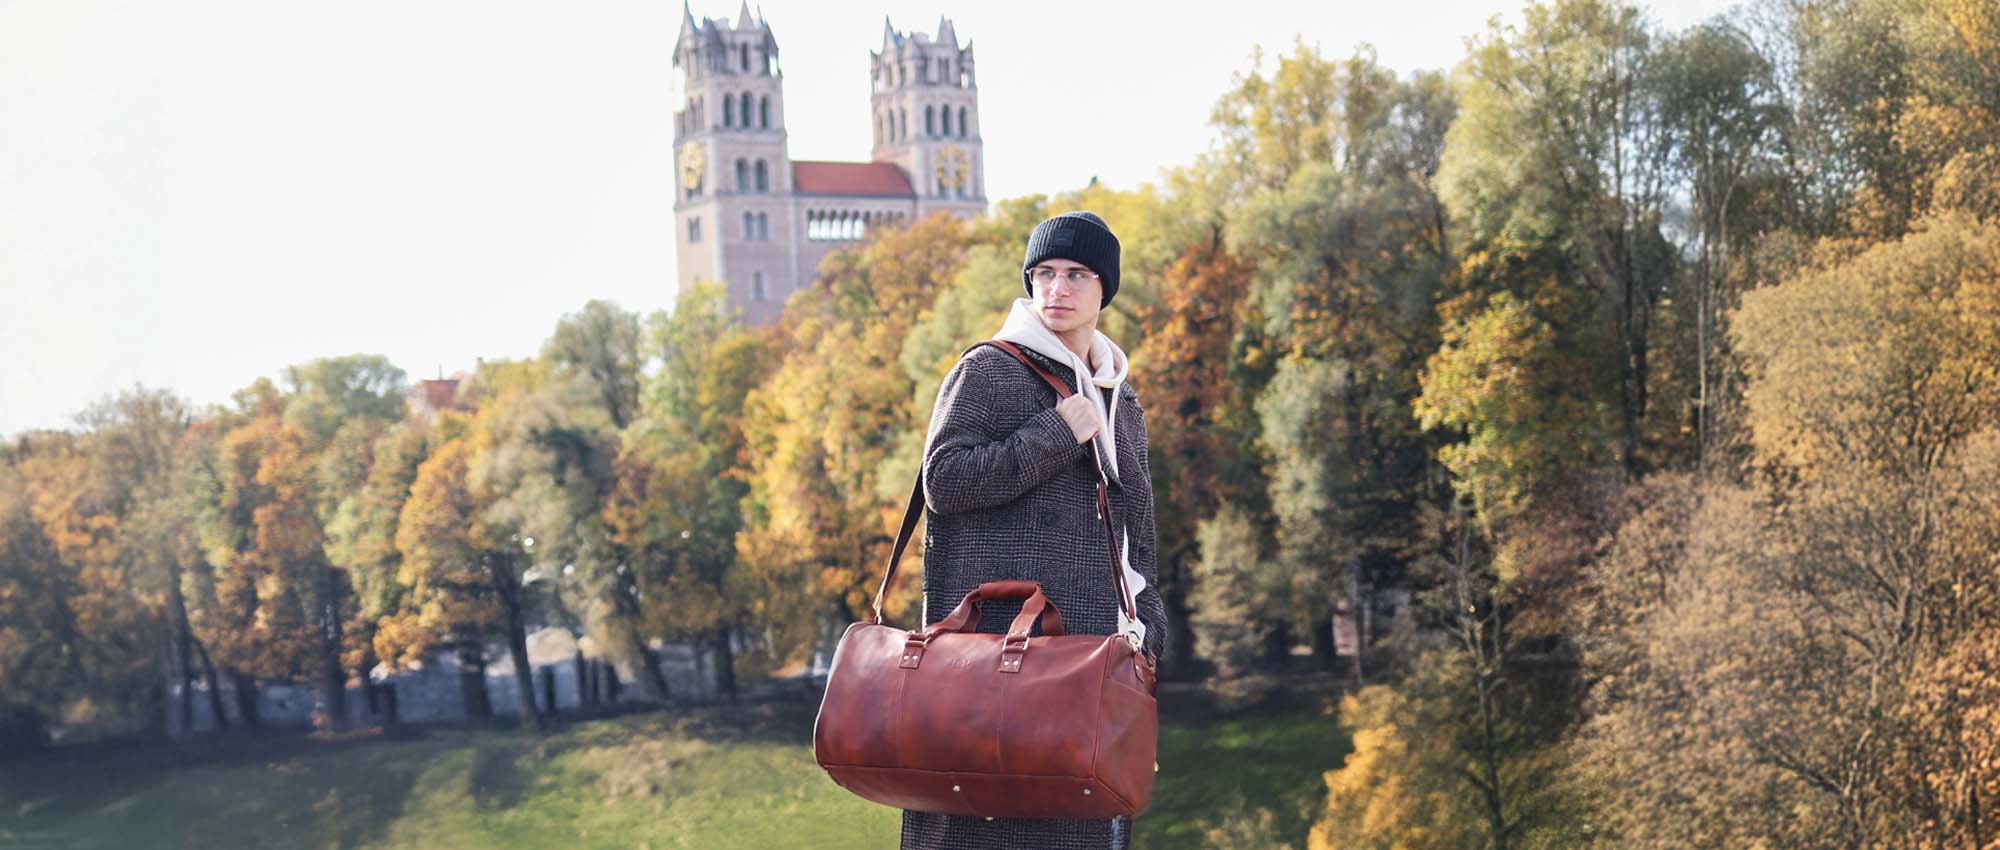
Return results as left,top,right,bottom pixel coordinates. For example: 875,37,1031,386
868,18,986,218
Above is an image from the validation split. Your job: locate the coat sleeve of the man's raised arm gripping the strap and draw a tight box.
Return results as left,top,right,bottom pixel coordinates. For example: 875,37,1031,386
924,348,1086,514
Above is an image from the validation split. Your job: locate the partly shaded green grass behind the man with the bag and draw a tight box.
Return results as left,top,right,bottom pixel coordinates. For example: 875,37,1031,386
0,684,1346,850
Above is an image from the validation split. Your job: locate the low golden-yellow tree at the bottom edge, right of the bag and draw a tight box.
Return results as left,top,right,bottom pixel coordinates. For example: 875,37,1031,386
1310,496,1582,850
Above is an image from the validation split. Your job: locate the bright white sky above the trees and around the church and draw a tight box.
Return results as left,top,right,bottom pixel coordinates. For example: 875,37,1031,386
0,0,1728,436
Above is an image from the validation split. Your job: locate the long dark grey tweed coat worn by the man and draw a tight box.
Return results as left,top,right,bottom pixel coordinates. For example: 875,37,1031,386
902,346,1168,850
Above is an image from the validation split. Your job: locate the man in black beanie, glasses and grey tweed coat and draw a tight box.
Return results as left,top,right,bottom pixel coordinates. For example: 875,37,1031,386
902,212,1168,850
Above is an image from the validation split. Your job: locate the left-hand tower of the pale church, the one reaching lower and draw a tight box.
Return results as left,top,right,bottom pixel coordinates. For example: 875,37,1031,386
674,2,800,324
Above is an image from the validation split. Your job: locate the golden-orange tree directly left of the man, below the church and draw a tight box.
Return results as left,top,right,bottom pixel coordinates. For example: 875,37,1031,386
736,216,974,664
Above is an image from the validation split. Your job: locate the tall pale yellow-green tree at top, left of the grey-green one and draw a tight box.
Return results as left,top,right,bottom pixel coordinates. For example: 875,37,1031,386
1438,0,1674,470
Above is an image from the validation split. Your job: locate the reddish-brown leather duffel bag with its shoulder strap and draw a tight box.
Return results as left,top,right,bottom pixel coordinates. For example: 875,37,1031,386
812,342,1160,818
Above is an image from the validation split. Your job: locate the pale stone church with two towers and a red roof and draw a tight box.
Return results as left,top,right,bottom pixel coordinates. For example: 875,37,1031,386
674,2,986,324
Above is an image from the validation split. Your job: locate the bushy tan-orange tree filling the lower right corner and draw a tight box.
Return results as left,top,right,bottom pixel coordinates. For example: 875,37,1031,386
1576,216,2000,848
